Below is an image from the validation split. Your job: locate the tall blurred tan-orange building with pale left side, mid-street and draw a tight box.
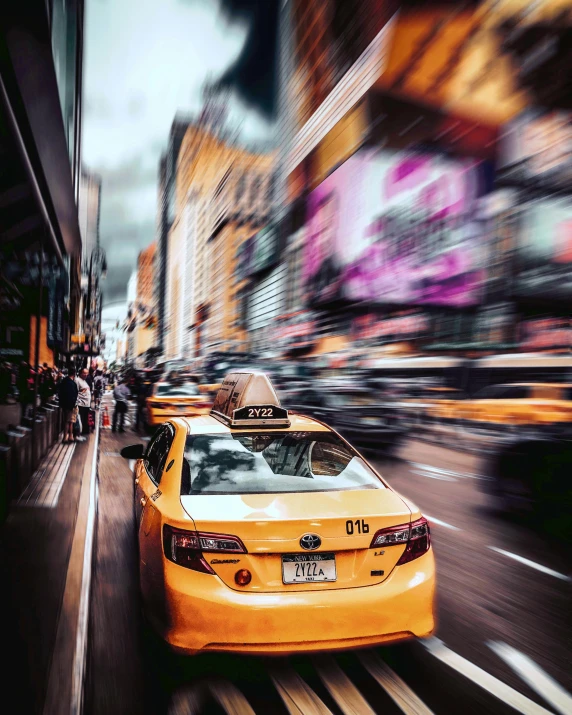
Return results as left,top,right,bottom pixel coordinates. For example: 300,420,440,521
166,110,273,358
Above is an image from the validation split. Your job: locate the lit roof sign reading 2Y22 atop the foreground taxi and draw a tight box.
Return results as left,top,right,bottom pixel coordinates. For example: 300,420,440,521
211,372,290,427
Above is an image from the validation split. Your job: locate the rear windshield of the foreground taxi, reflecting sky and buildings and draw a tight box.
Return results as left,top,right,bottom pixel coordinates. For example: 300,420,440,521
181,432,385,495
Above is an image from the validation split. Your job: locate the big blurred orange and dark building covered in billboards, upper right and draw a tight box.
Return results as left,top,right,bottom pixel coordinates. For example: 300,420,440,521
275,0,570,356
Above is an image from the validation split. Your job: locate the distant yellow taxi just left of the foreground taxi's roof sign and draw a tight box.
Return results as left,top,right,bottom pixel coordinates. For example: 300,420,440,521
145,382,213,428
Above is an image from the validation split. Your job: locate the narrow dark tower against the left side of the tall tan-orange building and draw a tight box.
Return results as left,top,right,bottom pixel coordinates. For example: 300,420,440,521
154,117,193,350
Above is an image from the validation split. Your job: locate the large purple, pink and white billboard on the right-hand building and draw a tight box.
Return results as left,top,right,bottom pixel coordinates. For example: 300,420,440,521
303,151,486,307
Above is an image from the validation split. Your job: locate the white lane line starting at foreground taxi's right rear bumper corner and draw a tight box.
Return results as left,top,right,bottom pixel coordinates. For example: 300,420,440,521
421,637,552,715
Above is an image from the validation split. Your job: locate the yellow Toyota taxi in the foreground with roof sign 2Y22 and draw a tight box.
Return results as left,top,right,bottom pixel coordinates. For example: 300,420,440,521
122,372,435,654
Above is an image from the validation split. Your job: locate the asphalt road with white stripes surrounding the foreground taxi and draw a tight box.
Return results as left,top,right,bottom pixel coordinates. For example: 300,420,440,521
85,397,572,715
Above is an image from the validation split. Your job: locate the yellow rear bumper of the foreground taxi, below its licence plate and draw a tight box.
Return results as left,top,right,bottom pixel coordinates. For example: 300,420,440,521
143,550,435,654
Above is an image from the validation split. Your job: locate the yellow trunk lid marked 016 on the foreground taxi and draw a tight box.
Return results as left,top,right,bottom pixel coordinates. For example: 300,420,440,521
181,488,411,593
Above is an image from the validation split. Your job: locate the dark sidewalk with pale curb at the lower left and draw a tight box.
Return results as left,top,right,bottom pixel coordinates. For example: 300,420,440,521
0,420,98,713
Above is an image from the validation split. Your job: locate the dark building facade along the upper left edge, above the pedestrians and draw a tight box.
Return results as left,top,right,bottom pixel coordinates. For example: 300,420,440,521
0,0,83,384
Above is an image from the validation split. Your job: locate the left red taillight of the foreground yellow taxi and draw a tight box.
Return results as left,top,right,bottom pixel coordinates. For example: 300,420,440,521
163,524,246,574
